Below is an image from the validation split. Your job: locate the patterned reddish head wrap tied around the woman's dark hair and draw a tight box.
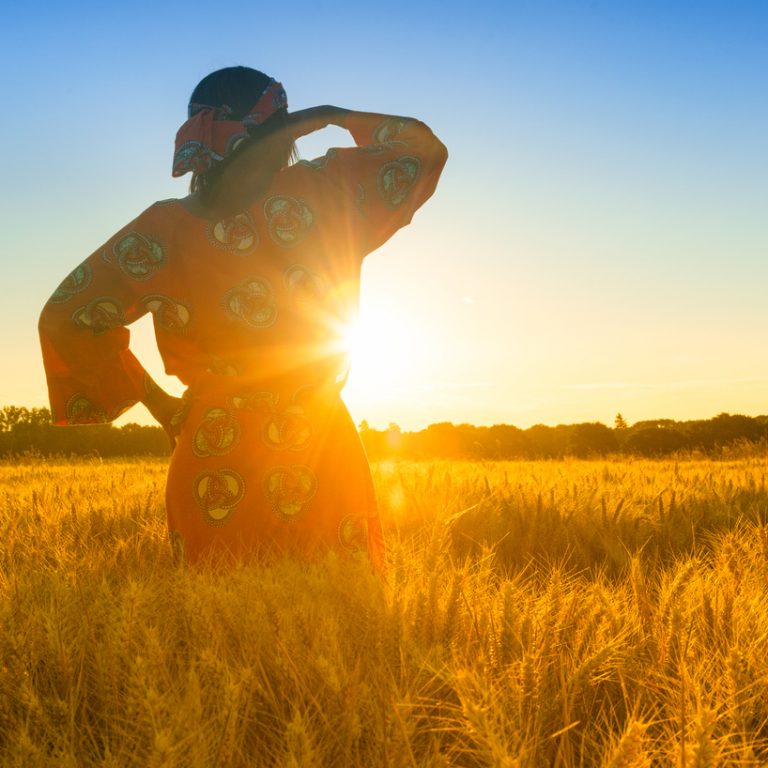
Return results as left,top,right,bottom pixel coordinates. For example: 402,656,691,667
173,80,288,176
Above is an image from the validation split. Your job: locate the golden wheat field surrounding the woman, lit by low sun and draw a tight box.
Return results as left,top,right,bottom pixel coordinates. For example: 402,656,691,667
0,456,768,768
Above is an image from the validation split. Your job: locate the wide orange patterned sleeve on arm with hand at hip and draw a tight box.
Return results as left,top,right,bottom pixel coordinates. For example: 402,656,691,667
38,217,166,425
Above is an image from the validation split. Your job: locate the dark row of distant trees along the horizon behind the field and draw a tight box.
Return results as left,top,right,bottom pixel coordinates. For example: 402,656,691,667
0,406,768,459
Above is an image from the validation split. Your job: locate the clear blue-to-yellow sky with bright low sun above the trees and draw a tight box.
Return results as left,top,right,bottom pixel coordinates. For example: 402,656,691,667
0,0,768,429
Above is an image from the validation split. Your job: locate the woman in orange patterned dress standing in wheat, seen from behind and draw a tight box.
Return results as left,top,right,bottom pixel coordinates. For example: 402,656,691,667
40,67,447,567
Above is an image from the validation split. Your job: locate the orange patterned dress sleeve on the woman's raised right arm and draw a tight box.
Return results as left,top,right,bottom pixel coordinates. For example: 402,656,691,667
314,112,448,255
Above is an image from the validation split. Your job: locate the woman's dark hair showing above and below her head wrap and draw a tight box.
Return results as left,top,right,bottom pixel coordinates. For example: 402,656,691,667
188,67,297,193
